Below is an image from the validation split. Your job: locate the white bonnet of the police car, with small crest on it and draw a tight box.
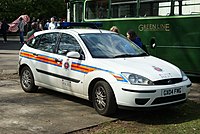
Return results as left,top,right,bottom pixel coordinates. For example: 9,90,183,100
93,56,182,81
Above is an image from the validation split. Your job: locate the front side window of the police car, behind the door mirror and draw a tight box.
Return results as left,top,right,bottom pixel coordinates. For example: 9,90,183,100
58,34,82,54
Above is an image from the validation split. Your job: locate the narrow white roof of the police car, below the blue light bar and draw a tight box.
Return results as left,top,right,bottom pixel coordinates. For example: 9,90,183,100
34,28,113,36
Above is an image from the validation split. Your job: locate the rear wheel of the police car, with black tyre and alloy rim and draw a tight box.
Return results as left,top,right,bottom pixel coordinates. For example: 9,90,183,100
20,66,38,93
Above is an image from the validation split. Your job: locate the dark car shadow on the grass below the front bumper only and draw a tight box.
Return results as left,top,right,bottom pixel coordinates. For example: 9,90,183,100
115,100,200,125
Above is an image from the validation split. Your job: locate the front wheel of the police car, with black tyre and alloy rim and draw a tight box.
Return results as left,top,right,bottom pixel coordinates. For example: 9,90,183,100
92,81,117,115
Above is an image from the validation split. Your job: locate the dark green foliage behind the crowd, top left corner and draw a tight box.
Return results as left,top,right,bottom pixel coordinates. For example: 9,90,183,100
0,0,66,22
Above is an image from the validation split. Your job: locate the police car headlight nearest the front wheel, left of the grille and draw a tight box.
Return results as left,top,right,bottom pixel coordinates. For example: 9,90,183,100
122,73,153,85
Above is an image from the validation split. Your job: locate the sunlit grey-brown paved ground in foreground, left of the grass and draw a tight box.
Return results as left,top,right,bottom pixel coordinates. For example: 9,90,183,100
0,80,116,134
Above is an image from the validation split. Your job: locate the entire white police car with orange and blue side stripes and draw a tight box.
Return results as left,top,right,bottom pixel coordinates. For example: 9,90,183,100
19,22,191,115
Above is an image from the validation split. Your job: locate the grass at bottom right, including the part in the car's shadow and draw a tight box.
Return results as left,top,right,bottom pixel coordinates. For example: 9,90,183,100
74,100,200,134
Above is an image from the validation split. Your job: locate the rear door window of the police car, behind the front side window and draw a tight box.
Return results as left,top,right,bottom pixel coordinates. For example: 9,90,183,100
35,33,59,53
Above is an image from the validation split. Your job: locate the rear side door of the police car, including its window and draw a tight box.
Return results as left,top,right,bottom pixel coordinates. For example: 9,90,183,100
32,33,62,86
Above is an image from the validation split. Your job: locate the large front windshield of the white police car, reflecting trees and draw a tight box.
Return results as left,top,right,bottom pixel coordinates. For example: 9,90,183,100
80,33,148,58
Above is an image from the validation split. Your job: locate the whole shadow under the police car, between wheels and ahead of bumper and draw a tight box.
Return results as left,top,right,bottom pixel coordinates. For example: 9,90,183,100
39,88,200,125
